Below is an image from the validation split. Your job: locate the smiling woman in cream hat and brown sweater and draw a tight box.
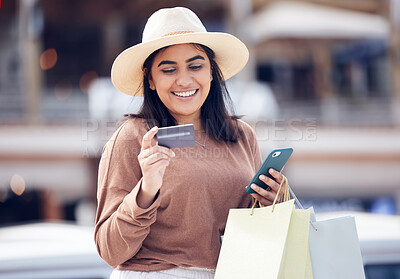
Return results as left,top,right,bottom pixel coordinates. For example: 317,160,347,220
95,7,282,278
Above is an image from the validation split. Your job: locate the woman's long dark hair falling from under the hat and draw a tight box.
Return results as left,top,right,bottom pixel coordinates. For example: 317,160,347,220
125,44,243,142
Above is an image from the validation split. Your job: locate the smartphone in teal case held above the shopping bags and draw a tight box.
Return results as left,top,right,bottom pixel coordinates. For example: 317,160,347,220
246,148,293,194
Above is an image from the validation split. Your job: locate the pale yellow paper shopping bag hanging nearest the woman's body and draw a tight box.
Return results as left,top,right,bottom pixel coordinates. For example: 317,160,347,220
215,178,312,279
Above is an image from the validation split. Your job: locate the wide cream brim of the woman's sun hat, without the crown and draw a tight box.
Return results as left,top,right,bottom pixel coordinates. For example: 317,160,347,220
111,32,249,96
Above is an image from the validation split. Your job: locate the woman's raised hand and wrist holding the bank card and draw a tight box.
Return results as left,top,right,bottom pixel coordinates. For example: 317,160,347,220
137,127,175,208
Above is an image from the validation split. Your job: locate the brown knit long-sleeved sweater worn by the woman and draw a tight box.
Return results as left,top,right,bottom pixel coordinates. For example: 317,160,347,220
95,118,262,271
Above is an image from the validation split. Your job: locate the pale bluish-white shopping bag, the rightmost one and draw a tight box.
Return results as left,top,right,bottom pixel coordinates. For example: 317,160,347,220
309,216,365,279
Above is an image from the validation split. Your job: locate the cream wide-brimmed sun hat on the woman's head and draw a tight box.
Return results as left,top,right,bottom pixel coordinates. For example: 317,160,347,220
111,7,249,96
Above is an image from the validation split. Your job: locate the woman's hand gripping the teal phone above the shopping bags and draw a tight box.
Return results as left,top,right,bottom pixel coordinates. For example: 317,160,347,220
251,169,284,206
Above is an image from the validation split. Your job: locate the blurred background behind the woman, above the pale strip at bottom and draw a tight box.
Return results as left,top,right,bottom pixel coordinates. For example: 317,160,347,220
0,0,400,278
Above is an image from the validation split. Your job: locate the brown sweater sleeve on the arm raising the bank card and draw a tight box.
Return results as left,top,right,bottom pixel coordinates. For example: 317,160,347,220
95,121,160,267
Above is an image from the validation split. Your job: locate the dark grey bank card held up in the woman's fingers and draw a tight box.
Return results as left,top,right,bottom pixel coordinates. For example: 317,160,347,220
156,124,196,148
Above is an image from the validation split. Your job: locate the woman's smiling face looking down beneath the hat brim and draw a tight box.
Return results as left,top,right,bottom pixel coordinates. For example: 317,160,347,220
149,44,212,124
